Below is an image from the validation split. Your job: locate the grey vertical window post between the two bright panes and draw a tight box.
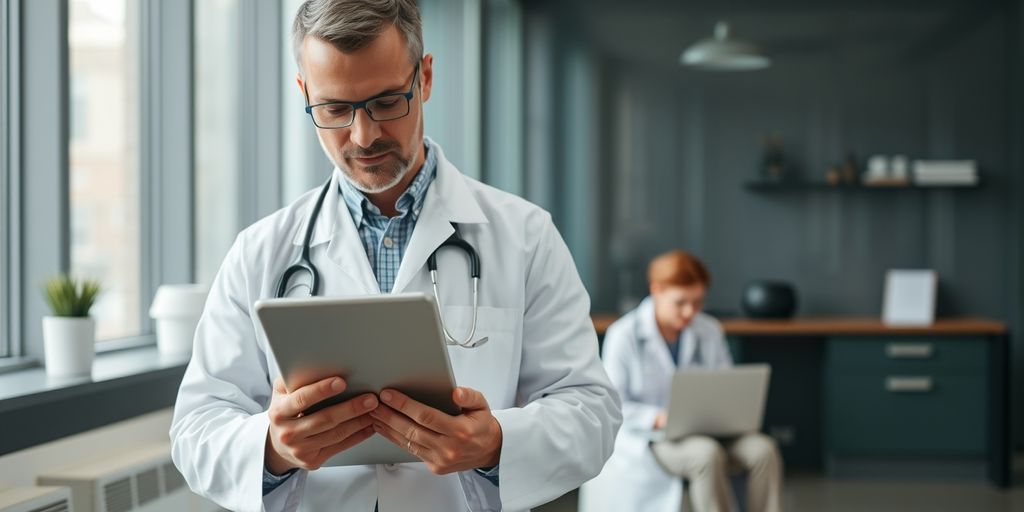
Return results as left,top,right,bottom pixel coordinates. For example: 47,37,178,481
134,0,196,351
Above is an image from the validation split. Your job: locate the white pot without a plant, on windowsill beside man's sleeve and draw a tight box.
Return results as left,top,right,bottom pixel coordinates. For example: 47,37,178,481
150,285,207,355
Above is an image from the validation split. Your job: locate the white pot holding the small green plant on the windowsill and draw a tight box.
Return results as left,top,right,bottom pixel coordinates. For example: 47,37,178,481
43,316,96,377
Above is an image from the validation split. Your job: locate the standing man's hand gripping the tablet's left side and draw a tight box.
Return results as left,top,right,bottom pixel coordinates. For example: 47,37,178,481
263,377,379,475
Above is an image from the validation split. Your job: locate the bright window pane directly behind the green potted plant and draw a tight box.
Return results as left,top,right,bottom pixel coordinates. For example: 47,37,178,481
68,0,140,340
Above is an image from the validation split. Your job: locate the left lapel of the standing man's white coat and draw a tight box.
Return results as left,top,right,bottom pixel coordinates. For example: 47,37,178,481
321,168,381,295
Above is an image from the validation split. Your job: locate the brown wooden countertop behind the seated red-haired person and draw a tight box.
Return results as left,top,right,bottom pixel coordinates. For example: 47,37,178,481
591,313,1007,336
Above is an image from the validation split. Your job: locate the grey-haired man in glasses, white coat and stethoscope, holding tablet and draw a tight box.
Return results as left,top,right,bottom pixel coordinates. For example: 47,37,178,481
171,0,622,512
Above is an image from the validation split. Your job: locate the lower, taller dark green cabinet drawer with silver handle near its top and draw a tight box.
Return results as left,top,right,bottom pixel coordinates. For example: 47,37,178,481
825,374,989,457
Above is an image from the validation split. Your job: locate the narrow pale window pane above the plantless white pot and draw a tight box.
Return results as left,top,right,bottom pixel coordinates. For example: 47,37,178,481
194,0,241,284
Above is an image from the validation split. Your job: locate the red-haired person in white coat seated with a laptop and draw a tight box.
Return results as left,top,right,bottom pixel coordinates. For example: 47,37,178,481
582,251,782,512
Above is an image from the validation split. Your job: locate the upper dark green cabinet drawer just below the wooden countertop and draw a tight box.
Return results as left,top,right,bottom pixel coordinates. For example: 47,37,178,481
825,336,989,375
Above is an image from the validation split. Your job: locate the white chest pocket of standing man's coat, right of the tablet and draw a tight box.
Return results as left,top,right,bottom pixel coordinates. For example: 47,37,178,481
444,306,522,409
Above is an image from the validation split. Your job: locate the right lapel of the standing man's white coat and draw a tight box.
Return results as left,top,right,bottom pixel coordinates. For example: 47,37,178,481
393,144,487,293
